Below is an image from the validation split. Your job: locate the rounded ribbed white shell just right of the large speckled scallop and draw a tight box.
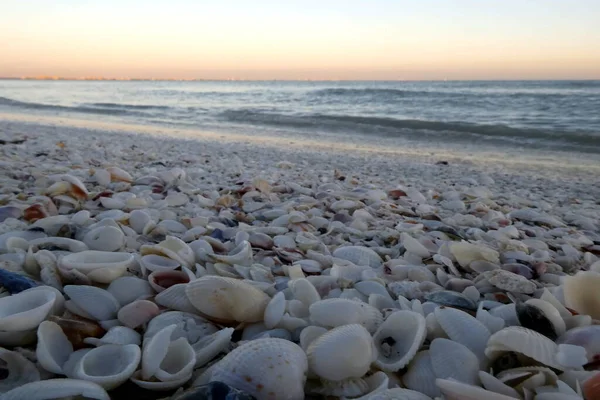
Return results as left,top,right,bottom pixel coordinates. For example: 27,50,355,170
306,324,377,381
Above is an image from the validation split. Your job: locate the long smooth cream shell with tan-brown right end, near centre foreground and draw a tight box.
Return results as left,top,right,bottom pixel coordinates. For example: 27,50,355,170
185,276,270,322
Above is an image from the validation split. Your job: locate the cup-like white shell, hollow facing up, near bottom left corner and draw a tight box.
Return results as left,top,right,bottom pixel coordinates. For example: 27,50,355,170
73,344,142,390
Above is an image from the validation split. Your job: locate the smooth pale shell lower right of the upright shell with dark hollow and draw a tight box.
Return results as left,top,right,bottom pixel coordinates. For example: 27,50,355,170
429,338,479,385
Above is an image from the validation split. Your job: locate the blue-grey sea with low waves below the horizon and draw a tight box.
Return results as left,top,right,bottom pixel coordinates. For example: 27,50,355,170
0,80,600,153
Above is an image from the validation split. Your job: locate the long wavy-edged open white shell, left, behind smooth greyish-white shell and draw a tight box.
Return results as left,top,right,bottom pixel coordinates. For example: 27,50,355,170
58,250,134,283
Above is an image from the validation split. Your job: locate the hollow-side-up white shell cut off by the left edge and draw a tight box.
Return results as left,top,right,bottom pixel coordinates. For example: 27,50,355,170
0,290,56,332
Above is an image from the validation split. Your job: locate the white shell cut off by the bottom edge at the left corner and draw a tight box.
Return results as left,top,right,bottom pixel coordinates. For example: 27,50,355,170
2,379,110,400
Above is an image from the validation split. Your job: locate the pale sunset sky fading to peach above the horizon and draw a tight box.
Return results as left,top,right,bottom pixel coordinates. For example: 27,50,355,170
0,0,600,80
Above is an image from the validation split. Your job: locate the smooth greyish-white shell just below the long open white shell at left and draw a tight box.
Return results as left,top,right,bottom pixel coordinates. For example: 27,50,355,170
65,285,120,321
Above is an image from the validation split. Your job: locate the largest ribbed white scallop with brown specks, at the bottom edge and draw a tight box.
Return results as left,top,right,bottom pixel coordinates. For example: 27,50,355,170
207,338,308,400
